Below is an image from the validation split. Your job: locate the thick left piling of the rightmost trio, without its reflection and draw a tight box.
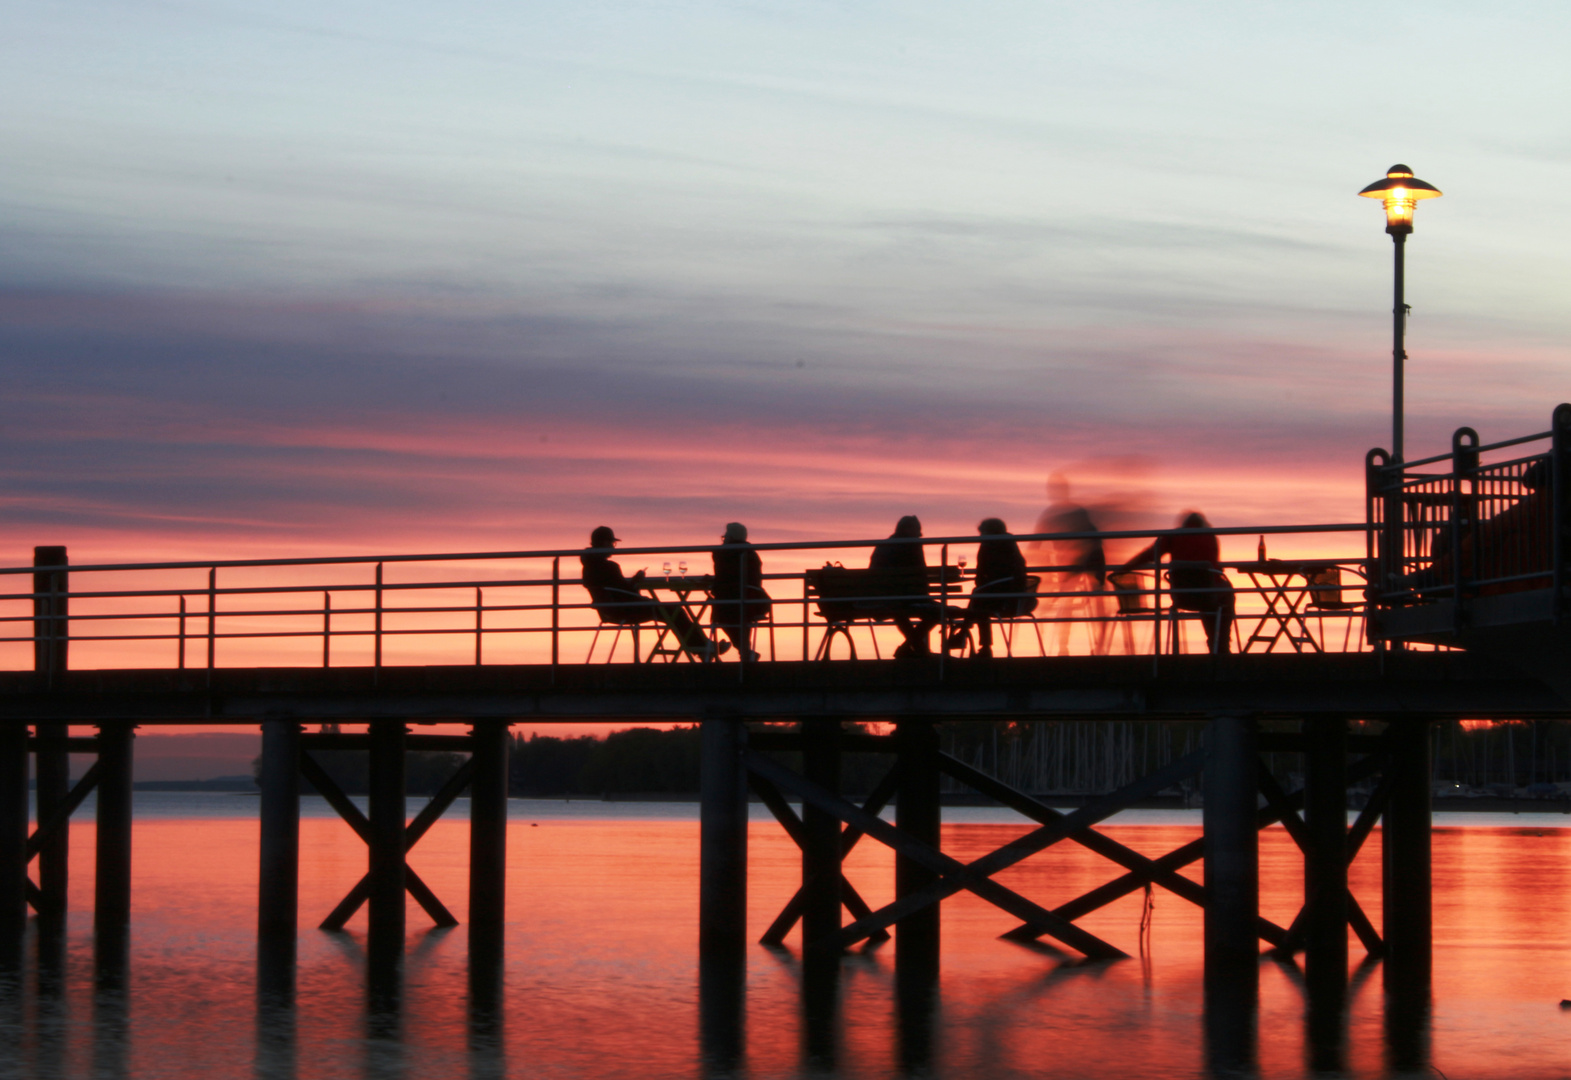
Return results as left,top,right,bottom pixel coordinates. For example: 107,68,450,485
1203,715,1260,986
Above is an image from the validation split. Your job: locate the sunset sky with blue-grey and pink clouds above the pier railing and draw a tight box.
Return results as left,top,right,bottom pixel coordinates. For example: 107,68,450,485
0,0,1571,564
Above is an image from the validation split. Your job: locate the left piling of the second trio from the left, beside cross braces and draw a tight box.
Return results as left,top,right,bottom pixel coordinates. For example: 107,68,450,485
256,720,300,1001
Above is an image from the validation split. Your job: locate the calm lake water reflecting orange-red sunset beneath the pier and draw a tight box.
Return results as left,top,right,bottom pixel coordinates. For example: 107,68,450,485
0,794,1571,1080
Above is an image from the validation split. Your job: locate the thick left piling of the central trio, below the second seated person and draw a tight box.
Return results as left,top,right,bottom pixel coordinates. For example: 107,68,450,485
698,717,748,957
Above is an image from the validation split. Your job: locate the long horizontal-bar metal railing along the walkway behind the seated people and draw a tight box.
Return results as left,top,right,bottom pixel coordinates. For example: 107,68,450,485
0,523,1368,673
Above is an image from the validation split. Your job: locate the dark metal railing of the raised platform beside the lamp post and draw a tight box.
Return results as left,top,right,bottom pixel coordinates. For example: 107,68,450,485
1365,404,1571,635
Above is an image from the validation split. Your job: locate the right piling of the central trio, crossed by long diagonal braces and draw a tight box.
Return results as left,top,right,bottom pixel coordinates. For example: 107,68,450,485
894,720,943,998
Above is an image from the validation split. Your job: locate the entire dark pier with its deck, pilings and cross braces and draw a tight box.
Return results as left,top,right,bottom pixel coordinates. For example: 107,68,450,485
0,407,1571,1069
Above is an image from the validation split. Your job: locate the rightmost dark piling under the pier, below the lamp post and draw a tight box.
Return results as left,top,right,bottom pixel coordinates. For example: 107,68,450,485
1381,720,1433,995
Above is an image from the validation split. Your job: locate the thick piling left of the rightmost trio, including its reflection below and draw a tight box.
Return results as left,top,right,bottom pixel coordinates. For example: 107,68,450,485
1203,715,1260,1074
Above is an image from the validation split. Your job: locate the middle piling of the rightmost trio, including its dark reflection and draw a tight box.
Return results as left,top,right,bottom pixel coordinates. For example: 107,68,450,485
1302,717,1348,1072
